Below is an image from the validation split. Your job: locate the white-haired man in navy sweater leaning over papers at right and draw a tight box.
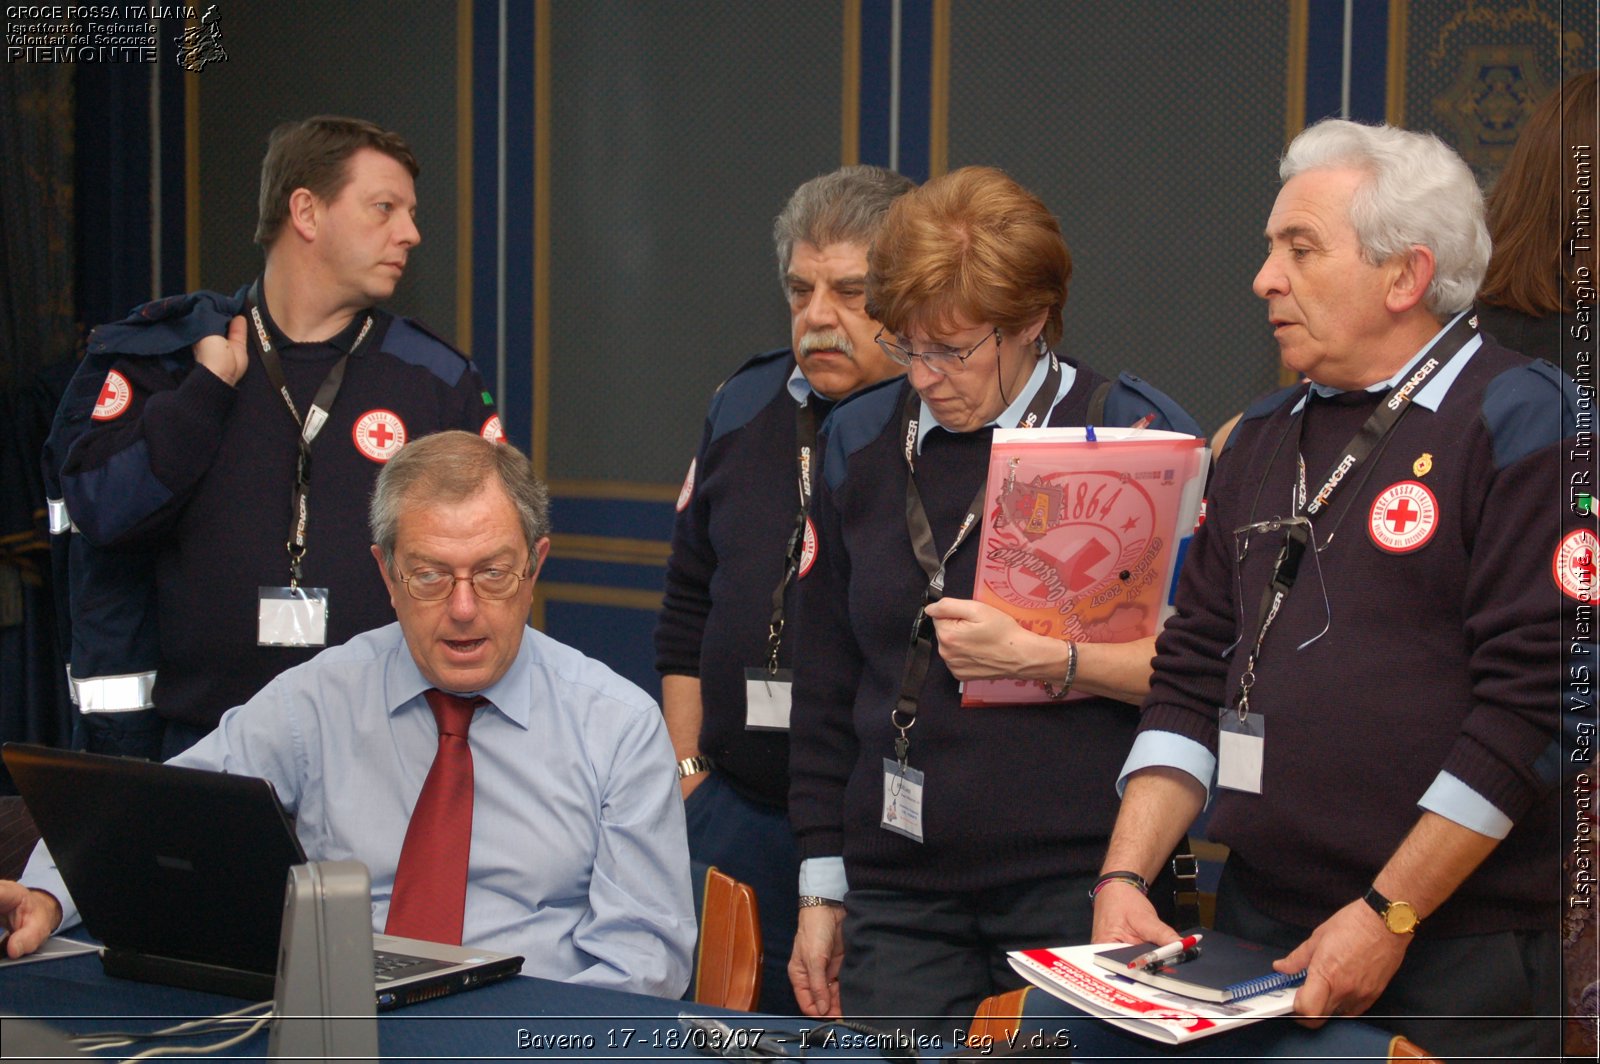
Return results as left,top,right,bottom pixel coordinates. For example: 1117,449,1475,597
1093,120,1574,1059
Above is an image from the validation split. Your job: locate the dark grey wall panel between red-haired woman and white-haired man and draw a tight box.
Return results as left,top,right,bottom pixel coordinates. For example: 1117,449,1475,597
949,0,1290,429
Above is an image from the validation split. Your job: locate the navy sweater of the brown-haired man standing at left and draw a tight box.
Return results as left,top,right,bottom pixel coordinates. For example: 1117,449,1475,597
61,293,499,728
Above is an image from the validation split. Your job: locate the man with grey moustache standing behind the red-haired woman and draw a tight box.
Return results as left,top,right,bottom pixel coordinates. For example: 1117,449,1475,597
656,166,914,1014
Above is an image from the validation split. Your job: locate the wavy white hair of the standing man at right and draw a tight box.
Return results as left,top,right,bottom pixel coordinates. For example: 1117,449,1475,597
1278,118,1491,318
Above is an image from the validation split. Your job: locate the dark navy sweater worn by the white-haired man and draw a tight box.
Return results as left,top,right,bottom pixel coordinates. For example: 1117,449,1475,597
1141,339,1592,934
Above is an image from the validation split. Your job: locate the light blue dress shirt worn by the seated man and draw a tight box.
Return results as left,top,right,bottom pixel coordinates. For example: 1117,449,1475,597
21,624,696,997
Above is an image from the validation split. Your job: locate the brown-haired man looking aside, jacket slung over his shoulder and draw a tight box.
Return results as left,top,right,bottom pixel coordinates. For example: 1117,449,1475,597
46,115,501,757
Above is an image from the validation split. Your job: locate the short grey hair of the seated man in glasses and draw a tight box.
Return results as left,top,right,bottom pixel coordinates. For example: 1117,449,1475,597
366,429,550,571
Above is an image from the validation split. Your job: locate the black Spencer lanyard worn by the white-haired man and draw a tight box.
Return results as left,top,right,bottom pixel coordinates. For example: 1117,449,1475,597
1237,314,1478,722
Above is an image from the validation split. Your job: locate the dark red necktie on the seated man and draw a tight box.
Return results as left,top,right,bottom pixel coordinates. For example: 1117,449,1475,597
384,690,486,946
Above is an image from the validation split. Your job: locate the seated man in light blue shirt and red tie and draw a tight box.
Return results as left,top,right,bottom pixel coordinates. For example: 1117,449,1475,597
0,432,696,997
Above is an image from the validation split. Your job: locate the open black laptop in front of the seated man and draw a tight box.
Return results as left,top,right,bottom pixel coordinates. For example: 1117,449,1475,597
3,742,523,1010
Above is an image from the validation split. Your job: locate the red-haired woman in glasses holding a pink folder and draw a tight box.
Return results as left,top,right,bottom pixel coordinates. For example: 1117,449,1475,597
789,166,1200,1037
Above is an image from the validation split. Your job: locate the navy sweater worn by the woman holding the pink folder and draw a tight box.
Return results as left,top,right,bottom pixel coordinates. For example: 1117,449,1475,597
789,365,1198,891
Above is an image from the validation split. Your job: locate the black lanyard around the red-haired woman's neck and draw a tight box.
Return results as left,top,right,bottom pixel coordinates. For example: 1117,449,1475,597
890,352,1061,765
